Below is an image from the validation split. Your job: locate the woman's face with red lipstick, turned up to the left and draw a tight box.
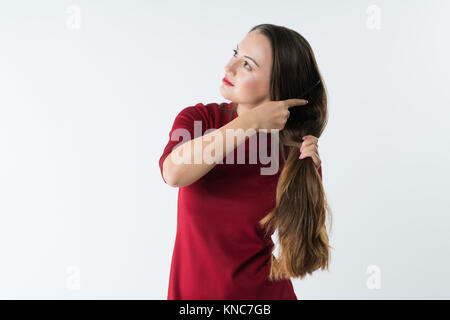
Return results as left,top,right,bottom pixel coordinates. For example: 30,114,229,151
220,30,272,106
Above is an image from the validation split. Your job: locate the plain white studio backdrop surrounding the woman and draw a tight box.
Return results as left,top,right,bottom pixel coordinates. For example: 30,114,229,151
0,0,450,299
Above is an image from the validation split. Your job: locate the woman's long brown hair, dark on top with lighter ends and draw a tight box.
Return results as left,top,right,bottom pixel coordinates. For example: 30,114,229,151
237,24,332,280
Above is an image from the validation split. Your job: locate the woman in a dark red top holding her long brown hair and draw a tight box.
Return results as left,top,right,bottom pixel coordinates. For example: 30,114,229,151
159,24,331,300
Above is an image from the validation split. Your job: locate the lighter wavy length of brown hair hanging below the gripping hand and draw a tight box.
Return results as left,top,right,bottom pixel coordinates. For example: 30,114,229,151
259,152,332,280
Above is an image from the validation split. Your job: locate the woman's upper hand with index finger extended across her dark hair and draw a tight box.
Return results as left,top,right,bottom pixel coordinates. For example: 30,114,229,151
244,99,308,130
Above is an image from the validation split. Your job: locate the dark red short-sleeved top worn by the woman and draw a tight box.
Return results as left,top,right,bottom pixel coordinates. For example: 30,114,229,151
159,103,322,300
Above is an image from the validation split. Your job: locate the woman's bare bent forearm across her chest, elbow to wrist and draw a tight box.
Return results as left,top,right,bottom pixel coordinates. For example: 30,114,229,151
163,113,258,187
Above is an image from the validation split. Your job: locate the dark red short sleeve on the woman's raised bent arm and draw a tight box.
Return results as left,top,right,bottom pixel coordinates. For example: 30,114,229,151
159,103,211,183
